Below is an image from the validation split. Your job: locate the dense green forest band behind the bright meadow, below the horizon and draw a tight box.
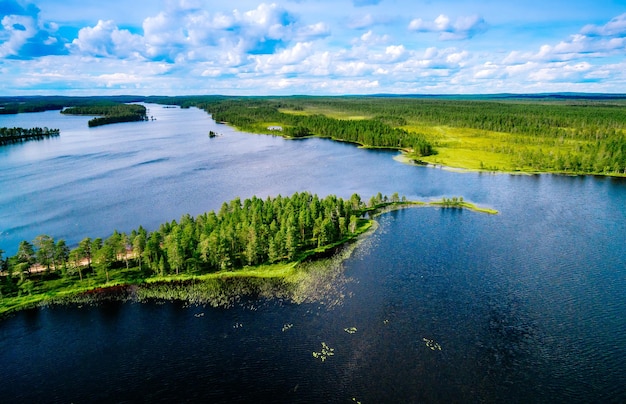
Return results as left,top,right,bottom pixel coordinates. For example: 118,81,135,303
272,97,626,140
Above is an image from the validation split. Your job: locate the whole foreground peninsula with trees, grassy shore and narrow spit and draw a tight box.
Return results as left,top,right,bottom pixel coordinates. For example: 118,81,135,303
0,192,497,315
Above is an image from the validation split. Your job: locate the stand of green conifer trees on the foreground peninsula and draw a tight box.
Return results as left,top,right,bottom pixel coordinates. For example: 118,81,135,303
0,192,386,296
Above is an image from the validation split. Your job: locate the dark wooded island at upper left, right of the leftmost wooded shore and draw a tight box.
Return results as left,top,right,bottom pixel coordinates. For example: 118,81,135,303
61,103,148,127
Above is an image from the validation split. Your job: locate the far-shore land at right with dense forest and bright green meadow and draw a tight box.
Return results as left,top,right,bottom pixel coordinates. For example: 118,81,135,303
188,97,626,175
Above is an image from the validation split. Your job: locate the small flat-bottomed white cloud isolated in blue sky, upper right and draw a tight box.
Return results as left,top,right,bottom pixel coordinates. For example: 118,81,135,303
408,14,487,41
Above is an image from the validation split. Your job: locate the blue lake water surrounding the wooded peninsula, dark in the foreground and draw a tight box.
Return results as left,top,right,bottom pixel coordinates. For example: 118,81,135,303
0,105,626,403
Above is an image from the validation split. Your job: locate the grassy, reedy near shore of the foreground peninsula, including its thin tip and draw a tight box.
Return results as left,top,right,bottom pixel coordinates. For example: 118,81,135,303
0,200,498,319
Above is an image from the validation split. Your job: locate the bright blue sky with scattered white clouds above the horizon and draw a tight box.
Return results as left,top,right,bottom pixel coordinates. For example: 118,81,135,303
0,0,626,95
